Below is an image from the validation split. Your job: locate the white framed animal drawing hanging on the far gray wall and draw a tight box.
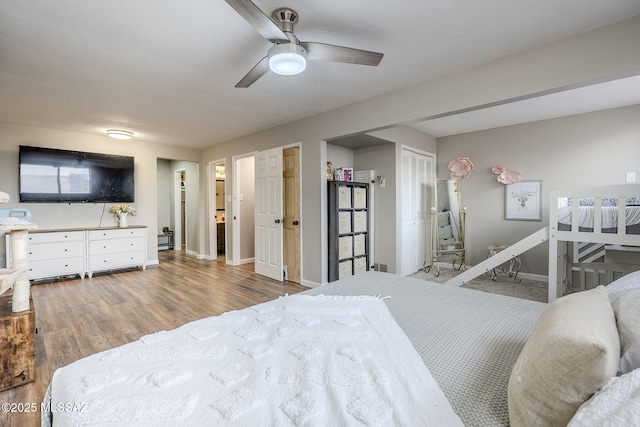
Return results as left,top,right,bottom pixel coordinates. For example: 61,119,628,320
504,181,542,221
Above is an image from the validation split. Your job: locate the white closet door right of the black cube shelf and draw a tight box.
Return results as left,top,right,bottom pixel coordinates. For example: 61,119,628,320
400,149,435,276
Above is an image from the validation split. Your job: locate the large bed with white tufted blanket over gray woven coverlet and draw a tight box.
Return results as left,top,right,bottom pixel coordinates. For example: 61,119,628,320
42,272,640,426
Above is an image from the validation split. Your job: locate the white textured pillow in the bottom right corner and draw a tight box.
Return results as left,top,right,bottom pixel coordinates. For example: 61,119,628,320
567,369,640,427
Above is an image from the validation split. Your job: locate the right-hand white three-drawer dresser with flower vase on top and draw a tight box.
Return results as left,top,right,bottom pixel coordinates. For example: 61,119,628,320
87,228,147,277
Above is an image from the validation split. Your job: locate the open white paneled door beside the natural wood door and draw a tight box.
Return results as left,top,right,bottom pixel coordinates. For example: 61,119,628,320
255,147,284,280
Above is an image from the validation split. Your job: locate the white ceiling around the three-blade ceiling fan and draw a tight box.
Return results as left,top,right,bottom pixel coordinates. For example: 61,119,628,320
0,0,640,148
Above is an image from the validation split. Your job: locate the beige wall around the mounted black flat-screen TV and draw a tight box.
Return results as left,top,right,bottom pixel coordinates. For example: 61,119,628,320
0,122,204,264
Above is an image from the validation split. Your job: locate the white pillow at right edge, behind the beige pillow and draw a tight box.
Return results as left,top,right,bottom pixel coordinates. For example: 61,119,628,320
606,271,640,375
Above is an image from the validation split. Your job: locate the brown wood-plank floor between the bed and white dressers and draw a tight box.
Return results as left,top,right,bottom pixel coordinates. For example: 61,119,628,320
0,251,307,427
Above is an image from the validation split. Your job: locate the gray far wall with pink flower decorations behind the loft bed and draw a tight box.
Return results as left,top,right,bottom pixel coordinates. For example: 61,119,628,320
438,105,640,275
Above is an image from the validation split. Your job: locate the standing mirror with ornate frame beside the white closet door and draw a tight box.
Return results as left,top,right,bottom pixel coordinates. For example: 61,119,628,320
424,179,466,276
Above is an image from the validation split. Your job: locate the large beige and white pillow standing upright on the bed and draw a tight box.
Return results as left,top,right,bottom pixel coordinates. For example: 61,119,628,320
507,286,620,427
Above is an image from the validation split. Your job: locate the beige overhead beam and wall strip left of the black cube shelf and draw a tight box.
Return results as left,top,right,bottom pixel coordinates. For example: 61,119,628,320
204,17,640,285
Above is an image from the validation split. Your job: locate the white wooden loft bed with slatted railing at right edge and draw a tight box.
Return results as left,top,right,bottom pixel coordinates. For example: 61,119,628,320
549,184,640,301
